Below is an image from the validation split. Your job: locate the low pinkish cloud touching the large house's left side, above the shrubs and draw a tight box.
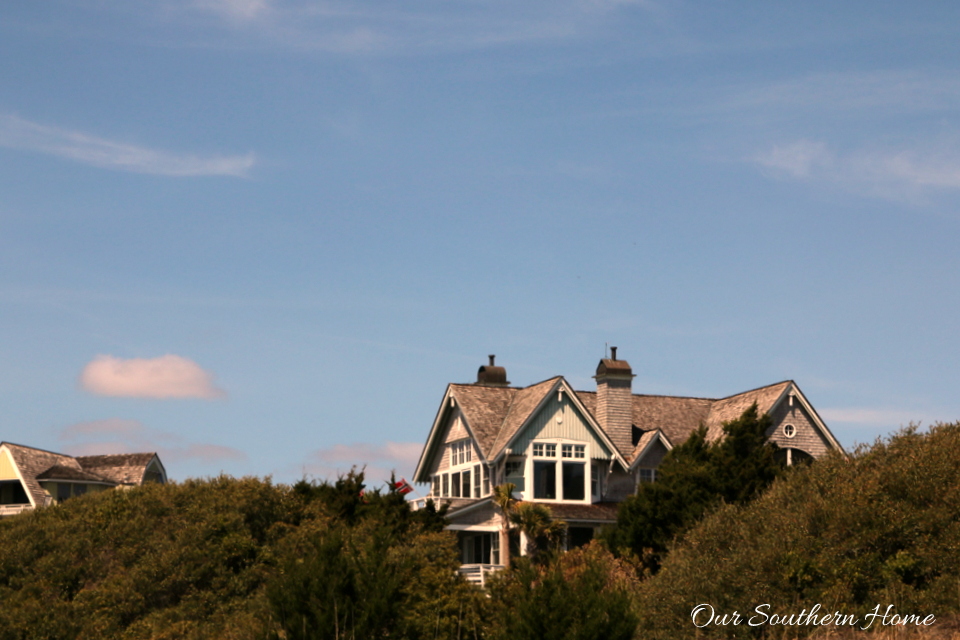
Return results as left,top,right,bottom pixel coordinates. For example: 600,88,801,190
298,442,423,487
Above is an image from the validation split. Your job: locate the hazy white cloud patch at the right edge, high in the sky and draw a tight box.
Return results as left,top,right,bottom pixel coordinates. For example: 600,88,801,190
751,140,960,200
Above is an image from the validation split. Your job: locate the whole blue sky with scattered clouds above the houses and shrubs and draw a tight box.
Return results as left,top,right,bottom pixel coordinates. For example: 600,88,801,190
0,0,960,482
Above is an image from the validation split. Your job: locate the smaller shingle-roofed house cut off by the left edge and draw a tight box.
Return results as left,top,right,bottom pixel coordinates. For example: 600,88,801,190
0,442,167,516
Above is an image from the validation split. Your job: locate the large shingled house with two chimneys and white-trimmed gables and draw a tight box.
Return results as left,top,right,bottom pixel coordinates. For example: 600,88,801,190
414,348,842,582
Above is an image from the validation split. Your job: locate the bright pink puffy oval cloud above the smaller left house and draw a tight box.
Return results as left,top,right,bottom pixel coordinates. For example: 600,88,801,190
80,354,226,399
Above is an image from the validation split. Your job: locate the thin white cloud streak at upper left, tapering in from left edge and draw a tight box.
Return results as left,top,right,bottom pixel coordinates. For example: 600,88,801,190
0,114,256,177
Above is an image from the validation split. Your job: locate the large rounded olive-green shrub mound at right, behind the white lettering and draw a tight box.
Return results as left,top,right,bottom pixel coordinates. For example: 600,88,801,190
639,423,960,638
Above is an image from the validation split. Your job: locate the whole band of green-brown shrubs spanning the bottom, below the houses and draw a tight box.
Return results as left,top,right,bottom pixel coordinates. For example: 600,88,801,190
0,424,960,640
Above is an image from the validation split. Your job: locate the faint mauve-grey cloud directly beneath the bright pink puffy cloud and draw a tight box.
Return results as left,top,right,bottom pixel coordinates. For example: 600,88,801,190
58,418,247,465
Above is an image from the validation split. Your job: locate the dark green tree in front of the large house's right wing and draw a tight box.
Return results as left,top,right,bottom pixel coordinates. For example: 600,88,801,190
605,404,783,571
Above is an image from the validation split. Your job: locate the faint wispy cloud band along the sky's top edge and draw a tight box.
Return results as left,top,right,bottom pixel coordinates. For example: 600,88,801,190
112,0,661,55
